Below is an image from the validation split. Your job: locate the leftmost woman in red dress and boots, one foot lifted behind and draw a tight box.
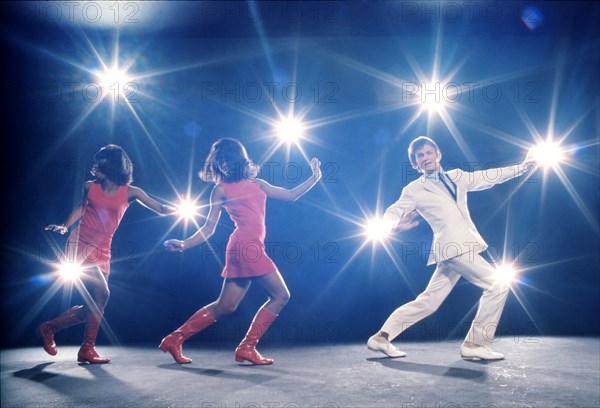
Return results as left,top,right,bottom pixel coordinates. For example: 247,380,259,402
38,145,175,364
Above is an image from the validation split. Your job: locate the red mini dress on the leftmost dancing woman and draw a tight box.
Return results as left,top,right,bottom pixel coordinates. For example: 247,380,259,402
66,183,129,275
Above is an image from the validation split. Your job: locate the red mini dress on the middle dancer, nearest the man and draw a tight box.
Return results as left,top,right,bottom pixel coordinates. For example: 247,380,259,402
219,180,277,278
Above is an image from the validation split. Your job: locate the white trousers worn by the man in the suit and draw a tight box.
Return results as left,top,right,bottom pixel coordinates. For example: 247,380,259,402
381,253,509,346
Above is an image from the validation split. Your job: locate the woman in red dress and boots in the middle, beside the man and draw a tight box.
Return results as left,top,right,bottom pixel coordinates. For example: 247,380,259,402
159,139,321,364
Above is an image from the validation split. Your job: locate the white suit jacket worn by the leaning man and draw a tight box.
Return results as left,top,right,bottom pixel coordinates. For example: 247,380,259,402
383,164,527,265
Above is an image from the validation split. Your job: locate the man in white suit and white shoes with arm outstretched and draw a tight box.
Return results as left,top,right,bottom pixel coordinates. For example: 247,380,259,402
367,136,535,360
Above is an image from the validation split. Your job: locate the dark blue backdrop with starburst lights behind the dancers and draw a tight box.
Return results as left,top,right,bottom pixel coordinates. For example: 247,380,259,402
1,1,600,347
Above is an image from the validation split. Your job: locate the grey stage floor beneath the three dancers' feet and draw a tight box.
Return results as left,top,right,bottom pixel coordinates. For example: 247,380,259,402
0,337,600,408
